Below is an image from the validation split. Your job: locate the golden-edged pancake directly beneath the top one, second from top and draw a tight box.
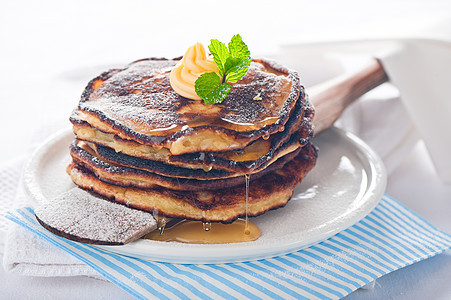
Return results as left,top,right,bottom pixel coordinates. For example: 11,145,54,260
71,99,314,173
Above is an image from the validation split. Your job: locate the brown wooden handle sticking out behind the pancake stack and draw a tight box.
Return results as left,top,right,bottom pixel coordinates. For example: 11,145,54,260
307,60,388,135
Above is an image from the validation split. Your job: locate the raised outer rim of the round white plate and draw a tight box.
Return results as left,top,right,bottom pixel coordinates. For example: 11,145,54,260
23,127,387,264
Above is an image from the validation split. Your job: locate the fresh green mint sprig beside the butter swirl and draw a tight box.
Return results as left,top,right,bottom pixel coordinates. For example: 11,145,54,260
194,34,251,104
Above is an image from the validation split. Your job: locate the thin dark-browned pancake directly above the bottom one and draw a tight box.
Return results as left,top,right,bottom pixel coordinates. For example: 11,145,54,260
70,140,301,191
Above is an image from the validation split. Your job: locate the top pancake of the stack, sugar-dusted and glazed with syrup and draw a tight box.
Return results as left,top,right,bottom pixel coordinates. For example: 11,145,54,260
77,59,305,155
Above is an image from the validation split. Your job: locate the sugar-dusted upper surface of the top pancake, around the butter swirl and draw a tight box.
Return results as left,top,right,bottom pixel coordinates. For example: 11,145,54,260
79,60,299,136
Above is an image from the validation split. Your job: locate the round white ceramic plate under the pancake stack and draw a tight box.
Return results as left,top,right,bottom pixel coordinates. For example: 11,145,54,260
24,128,386,263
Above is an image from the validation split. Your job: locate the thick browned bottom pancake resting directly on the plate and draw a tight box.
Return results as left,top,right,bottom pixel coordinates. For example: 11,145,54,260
67,143,317,223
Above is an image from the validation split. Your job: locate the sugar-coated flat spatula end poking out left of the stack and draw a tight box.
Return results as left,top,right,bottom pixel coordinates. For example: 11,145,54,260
35,188,156,244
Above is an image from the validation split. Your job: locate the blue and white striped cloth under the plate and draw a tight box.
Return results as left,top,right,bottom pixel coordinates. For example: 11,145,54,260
7,196,451,299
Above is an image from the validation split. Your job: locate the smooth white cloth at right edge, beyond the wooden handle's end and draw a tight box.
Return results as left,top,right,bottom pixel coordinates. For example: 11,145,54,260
380,35,451,183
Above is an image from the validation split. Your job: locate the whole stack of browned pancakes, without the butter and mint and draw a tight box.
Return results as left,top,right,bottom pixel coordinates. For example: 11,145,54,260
67,59,316,222
